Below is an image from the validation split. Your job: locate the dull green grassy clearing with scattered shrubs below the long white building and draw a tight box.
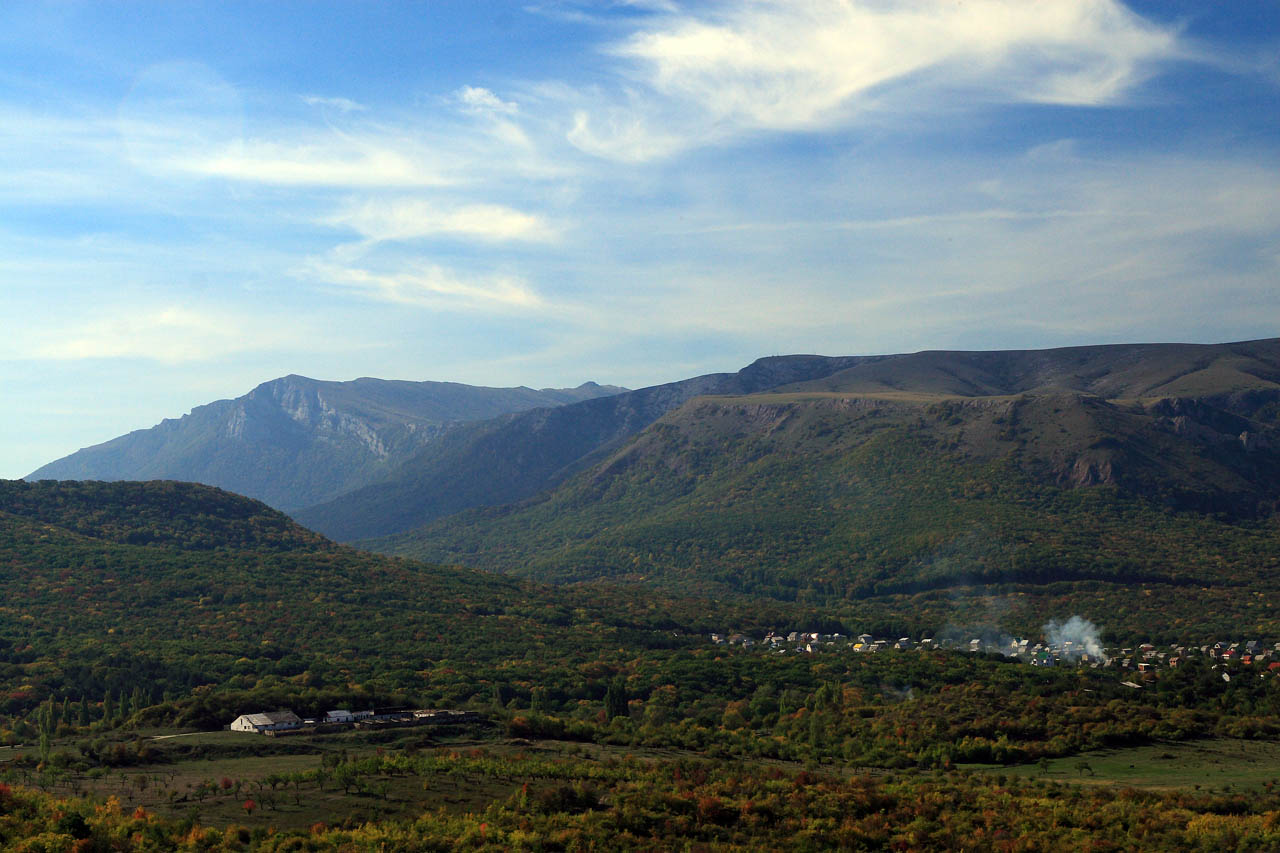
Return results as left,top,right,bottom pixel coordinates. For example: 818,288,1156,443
0,730,727,829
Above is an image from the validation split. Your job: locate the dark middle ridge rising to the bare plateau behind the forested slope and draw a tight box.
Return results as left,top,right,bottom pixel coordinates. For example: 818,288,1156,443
294,339,1280,540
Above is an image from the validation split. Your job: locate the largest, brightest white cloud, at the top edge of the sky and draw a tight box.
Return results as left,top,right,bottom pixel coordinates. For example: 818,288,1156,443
570,0,1179,160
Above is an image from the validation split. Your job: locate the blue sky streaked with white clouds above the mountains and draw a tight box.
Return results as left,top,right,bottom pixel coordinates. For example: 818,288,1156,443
0,0,1280,478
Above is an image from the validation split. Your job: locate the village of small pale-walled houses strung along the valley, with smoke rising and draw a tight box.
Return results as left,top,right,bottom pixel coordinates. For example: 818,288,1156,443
710,631,1280,688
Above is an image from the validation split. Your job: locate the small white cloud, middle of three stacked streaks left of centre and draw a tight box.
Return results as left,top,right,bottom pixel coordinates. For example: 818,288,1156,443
321,199,557,242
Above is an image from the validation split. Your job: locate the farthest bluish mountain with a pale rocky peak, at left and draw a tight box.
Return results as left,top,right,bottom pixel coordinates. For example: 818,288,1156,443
26,375,623,510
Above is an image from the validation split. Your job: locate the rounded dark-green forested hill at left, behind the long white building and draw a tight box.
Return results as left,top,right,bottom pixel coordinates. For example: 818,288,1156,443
0,480,757,727
